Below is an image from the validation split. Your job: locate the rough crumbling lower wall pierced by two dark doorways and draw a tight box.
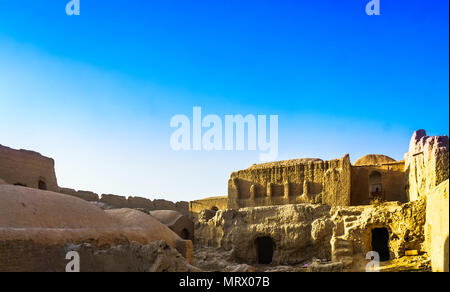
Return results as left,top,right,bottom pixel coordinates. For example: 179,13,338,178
194,200,425,270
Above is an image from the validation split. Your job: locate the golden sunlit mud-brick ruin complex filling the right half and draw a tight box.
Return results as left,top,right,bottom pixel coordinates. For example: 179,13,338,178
191,130,449,271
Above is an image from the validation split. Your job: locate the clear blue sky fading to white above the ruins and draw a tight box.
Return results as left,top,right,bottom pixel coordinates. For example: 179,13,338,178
0,0,449,201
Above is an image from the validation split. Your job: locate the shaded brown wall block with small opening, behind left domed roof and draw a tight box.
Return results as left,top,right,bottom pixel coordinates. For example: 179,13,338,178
0,145,59,192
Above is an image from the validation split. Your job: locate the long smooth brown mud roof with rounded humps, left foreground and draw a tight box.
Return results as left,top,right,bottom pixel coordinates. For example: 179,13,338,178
0,185,193,262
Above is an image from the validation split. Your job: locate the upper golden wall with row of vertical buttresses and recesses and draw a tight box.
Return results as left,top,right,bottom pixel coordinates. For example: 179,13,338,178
228,155,351,209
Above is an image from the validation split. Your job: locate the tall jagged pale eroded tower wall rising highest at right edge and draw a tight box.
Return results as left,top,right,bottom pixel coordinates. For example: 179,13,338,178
405,130,449,201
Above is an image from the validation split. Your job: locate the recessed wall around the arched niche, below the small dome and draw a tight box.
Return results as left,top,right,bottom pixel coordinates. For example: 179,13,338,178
351,161,407,206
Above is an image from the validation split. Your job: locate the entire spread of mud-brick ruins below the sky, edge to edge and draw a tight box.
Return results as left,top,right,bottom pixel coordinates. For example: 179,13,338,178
0,130,449,272
